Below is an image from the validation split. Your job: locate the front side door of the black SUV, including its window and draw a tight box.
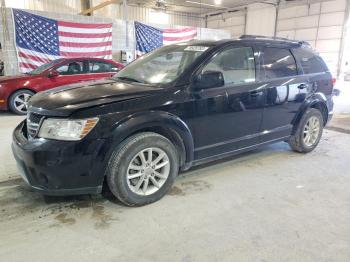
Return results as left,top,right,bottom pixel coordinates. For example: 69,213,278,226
190,46,264,159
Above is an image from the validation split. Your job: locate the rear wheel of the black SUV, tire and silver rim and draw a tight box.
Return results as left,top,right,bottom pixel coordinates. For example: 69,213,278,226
288,108,324,153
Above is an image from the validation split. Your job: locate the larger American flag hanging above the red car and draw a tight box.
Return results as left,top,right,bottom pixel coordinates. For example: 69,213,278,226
13,9,112,72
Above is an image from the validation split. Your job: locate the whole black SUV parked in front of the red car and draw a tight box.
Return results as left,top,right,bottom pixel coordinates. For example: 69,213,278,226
12,36,333,206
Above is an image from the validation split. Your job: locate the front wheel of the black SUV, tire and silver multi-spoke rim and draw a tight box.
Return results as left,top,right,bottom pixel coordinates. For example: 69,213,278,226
106,132,179,206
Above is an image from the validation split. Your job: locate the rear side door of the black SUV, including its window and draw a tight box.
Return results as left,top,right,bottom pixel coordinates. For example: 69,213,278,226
259,47,309,142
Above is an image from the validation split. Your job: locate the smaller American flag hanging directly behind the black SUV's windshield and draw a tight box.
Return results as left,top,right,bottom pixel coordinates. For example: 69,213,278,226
135,22,197,56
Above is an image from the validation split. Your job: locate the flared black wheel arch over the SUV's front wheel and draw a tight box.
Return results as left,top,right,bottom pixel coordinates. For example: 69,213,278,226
108,111,194,170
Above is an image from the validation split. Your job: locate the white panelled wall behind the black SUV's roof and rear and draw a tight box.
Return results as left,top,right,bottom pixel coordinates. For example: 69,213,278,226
207,0,347,75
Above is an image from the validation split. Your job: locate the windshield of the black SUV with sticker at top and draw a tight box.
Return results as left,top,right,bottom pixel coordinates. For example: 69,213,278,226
114,44,208,86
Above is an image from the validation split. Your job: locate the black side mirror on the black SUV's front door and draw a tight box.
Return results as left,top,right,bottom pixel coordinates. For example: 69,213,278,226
193,71,225,90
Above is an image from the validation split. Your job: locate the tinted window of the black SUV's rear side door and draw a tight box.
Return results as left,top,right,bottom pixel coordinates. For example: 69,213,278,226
262,47,297,79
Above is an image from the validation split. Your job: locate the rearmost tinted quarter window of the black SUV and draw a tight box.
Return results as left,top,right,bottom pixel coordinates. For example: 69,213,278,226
293,48,328,74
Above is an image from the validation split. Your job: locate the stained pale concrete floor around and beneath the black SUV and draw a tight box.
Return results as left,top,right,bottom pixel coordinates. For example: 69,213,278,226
0,81,350,262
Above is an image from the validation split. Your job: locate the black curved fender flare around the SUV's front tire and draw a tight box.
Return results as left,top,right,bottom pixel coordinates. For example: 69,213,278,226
106,111,194,166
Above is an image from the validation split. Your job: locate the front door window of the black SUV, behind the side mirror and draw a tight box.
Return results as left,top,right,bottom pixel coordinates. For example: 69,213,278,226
202,47,255,84
